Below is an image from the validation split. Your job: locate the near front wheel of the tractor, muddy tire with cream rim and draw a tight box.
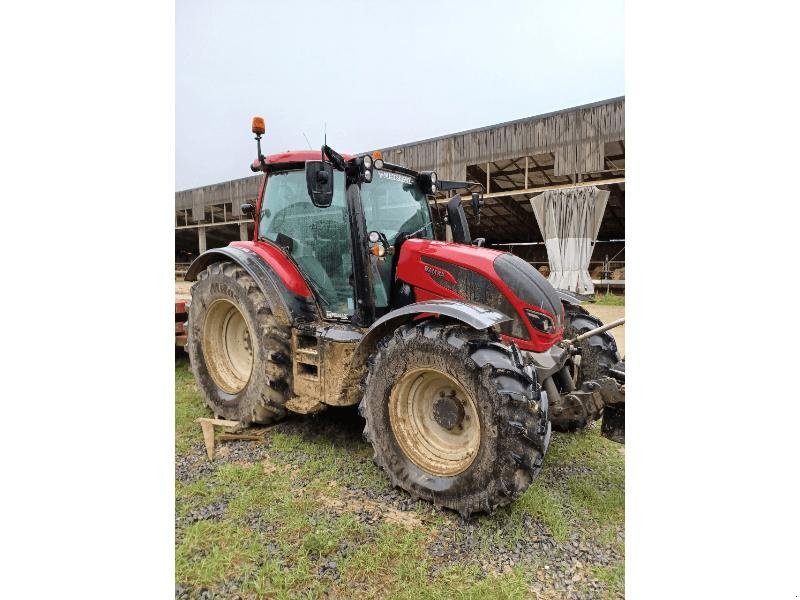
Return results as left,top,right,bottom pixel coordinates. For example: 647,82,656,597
359,319,550,518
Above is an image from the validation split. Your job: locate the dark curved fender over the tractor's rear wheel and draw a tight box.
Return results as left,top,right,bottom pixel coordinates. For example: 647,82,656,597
185,246,319,325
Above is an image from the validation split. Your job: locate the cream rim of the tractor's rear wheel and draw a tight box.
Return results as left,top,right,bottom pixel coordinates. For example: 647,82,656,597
203,300,253,394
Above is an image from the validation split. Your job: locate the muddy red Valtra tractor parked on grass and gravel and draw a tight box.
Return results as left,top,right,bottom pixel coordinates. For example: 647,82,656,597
186,118,624,516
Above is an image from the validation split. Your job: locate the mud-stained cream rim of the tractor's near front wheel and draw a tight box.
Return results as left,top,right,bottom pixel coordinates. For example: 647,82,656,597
389,368,481,476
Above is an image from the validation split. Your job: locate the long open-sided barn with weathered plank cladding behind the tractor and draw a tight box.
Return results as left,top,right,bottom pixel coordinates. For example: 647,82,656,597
175,97,625,292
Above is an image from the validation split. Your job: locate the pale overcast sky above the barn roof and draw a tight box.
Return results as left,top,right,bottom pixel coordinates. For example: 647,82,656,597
175,0,625,190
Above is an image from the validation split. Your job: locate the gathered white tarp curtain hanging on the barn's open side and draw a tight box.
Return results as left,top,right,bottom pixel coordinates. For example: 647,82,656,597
531,186,610,294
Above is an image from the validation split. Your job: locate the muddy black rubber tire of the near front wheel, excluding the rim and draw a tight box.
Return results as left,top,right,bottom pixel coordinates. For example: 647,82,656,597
359,318,550,518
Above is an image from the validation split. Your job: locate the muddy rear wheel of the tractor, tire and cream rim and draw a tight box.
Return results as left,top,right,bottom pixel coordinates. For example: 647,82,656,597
186,262,292,425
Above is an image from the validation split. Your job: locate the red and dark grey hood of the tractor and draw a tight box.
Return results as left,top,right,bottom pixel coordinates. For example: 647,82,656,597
397,239,564,352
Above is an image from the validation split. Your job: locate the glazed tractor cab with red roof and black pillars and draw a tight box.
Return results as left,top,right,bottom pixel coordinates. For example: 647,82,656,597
253,146,444,326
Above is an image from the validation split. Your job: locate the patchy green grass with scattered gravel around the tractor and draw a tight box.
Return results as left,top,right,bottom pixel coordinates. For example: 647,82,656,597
175,362,624,599
